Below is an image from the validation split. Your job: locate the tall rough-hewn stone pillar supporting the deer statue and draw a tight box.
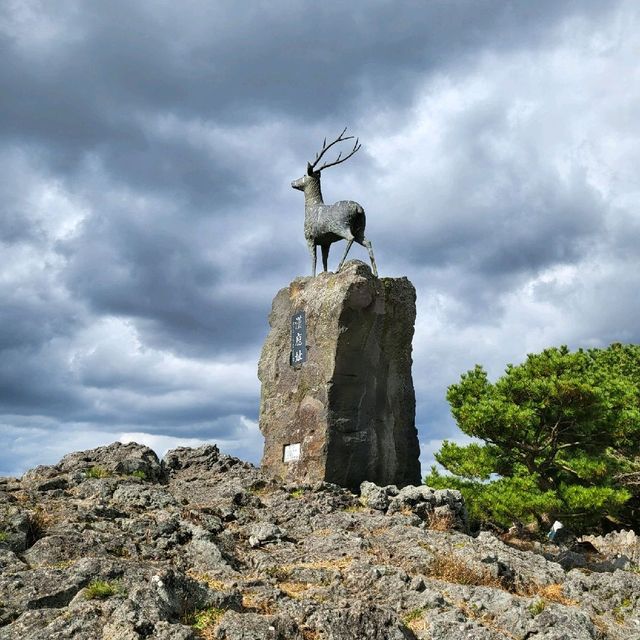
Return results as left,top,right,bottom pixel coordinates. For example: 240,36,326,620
258,260,420,489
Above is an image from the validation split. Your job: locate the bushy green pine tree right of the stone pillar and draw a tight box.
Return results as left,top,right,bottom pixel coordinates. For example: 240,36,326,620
425,343,640,529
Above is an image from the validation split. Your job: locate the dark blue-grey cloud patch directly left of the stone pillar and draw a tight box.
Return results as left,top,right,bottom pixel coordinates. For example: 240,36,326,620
60,195,278,356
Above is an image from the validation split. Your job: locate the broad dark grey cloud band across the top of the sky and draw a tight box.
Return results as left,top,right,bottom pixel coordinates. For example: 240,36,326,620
0,1,602,186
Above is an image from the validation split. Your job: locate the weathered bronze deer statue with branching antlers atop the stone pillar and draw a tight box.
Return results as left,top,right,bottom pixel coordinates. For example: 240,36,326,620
291,127,378,277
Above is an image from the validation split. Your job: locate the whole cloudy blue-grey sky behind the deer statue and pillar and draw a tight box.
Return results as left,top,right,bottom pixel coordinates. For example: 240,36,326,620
0,0,640,475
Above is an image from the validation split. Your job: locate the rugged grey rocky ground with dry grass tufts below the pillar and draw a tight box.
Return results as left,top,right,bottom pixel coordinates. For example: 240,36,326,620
0,444,640,640
